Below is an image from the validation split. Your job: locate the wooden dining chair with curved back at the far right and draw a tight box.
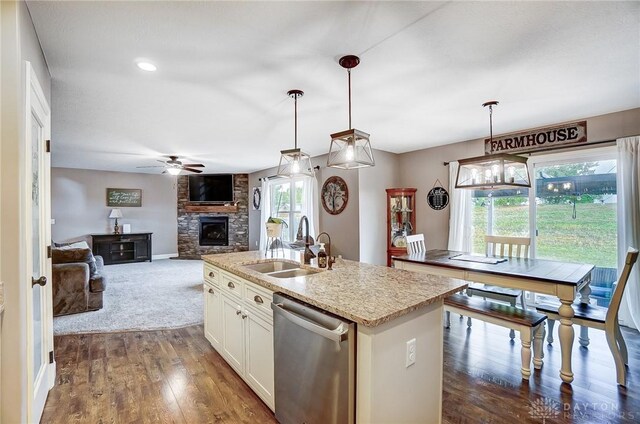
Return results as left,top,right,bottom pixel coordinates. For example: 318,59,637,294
536,247,638,386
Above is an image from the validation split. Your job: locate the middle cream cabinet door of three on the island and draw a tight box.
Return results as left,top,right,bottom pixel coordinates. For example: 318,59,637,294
220,294,244,375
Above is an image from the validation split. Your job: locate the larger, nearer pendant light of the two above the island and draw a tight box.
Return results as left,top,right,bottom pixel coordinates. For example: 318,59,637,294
327,55,376,169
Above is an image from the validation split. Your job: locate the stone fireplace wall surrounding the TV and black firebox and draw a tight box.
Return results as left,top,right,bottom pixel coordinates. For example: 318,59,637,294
178,174,249,259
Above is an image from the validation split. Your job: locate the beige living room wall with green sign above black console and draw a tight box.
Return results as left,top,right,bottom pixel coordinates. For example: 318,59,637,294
51,168,178,255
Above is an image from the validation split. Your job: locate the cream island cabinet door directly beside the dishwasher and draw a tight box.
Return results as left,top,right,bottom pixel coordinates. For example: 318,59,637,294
244,309,275,410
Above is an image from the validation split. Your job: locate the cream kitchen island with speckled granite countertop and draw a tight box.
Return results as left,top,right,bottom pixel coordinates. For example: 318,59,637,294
203,250,466,424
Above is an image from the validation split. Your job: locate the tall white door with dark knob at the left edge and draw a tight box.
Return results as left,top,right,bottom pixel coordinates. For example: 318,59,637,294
24,62,55,422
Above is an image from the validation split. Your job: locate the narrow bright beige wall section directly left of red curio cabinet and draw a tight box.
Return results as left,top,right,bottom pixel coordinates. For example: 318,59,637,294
358,150,401,265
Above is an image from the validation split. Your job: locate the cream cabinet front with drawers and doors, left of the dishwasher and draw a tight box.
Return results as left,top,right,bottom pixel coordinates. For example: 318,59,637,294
204,264,275,410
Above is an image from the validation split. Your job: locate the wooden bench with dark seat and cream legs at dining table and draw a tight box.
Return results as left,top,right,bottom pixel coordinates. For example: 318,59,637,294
444,294,547,380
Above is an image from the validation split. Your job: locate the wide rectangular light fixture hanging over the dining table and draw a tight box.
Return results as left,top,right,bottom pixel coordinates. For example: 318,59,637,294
456,100,531,190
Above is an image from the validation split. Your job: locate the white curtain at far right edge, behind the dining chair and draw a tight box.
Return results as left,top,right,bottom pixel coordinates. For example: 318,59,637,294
617,136,640,329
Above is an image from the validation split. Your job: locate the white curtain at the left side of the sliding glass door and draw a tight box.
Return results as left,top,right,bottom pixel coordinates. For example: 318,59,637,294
449,161,473,252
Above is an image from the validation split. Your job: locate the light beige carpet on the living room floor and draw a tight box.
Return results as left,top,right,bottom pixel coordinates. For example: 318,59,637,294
53,259,203,335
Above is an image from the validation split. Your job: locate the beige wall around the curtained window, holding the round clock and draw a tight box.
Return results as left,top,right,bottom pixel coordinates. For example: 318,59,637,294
249,155,360,260
